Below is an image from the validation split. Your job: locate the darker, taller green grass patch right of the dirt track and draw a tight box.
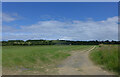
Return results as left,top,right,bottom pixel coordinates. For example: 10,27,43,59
90,45,120,73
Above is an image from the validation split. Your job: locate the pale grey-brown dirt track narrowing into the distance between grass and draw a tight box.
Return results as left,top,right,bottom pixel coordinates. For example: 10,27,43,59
58,46,112,75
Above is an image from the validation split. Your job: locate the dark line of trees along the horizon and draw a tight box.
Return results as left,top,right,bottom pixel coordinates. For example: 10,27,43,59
1,40,120,46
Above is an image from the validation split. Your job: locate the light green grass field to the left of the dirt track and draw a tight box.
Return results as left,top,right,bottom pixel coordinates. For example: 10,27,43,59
2,45,91,74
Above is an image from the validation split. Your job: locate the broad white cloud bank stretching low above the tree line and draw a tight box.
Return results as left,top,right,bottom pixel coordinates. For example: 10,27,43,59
3,16,118,40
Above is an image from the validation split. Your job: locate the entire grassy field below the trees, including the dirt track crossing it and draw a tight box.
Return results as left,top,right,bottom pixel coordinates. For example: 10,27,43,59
3,45,119,75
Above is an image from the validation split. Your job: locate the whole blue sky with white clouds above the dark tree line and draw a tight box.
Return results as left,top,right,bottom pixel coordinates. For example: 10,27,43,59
2,2,118,41
